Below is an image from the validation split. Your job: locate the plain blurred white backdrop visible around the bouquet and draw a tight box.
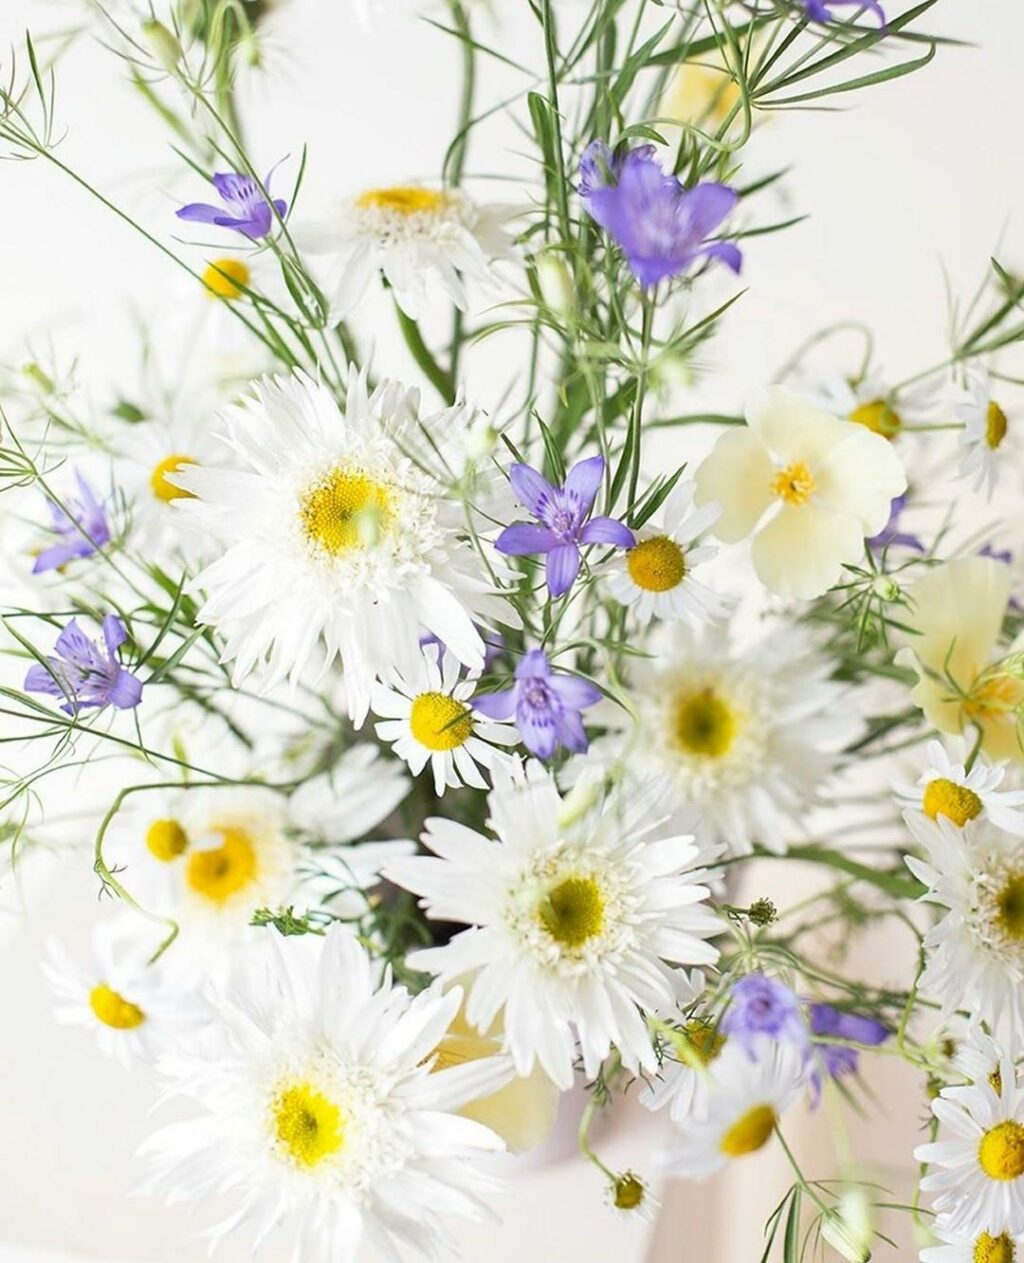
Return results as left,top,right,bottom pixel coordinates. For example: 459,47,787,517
0,0,1024,1263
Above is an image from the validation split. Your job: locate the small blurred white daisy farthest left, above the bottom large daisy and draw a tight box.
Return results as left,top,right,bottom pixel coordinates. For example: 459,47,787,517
43,917,191,1066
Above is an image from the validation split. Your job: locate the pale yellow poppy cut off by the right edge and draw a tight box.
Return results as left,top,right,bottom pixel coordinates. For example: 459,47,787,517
898,557,1024,763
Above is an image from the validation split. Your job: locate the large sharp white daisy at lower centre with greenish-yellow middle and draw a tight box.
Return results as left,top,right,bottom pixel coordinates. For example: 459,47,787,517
385,763,720,1089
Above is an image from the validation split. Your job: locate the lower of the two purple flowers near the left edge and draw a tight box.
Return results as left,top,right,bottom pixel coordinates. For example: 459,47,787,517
25,614,143,715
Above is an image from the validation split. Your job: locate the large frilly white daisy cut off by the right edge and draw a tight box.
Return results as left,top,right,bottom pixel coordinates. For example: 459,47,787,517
904,812,1024,1032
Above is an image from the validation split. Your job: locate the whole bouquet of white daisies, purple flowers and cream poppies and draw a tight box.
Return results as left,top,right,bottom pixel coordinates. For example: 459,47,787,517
0,0,1024,1263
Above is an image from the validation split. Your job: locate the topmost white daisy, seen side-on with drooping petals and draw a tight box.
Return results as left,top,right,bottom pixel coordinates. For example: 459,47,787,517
298,186,516,320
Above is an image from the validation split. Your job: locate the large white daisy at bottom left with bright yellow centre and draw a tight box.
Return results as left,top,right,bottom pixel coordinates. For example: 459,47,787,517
143,926,510,1263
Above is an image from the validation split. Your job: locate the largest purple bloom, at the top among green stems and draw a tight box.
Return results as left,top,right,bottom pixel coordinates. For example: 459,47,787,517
580,140,742,288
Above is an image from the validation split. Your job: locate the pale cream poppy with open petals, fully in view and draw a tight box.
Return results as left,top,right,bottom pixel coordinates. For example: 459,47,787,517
697,386,907,599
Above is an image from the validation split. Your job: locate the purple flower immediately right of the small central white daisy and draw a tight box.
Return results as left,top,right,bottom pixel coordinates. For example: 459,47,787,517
472,649,601,759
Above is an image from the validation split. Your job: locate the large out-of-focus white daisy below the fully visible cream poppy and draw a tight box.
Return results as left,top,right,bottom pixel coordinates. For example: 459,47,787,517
611,625,860,855
